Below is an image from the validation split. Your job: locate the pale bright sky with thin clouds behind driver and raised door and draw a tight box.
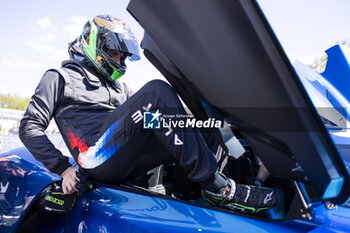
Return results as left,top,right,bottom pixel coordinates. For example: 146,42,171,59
0,0,350,97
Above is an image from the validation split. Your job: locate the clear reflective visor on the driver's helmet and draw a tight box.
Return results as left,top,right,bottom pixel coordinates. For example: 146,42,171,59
106,27,140,61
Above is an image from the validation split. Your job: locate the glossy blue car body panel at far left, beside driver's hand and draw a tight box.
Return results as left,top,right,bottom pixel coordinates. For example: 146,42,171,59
0,149,60,232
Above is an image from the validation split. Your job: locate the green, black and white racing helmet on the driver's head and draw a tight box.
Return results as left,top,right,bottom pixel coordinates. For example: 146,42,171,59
79,15,140,82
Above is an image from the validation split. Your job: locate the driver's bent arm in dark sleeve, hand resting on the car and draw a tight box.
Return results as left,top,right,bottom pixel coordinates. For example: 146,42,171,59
19,71,78,193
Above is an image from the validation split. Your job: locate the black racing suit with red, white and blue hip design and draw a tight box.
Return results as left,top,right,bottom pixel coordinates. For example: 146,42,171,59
20,60,217,183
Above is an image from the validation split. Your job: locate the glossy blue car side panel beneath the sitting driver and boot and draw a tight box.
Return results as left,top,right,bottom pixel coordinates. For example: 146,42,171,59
66,186,316,233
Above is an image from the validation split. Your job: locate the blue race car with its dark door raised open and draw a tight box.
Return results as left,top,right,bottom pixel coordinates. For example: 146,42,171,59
0,0,350,233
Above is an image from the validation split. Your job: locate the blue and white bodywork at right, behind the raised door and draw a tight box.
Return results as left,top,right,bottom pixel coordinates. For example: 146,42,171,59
294,45,350,168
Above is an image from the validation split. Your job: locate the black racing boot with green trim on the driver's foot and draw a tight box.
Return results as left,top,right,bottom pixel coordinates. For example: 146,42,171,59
202,178,279,213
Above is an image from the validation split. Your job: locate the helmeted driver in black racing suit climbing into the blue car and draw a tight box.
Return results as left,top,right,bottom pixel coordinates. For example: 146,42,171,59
20,15,279,213
